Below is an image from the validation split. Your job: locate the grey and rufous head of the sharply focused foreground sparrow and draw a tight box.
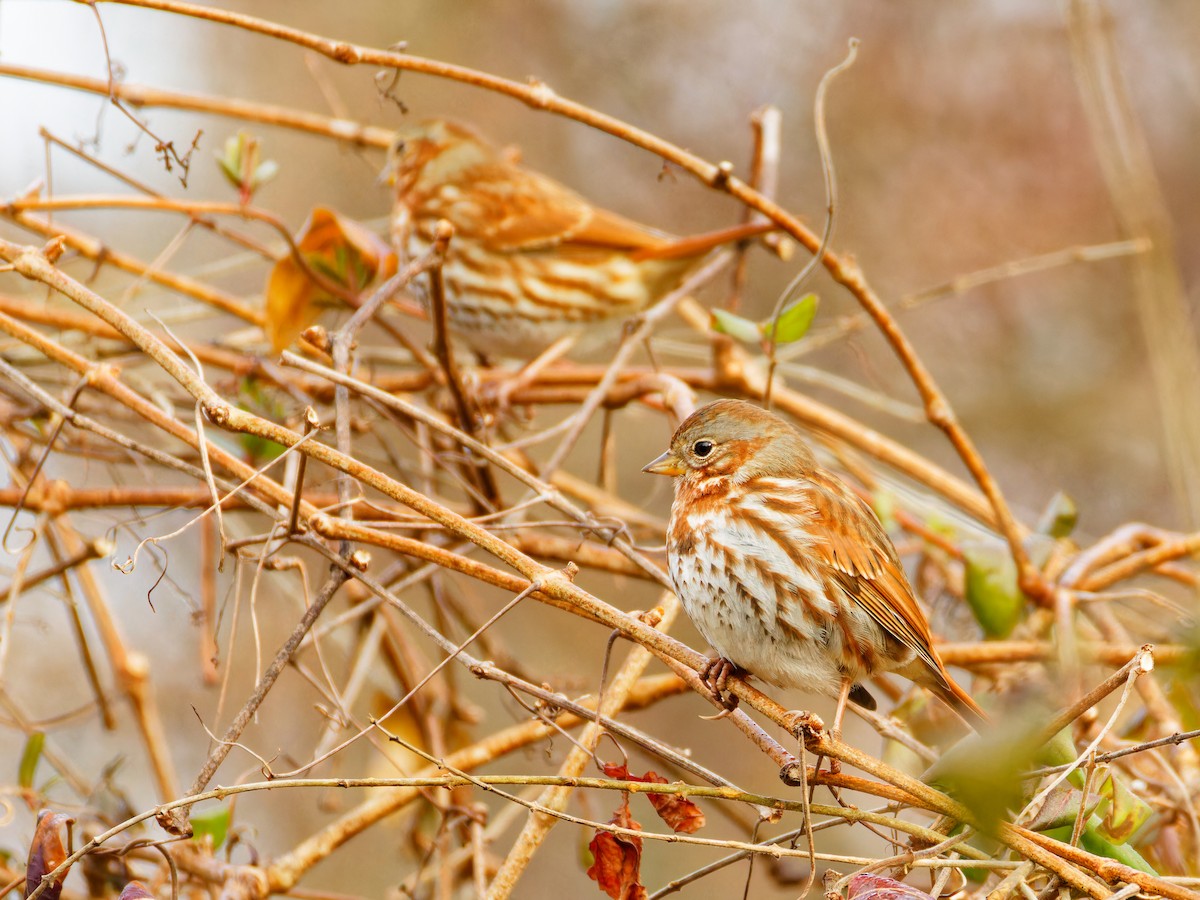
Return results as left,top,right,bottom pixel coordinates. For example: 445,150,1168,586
642,400,816,481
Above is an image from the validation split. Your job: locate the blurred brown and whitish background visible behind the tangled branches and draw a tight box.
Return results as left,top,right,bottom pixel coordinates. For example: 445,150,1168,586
0,0,1200,896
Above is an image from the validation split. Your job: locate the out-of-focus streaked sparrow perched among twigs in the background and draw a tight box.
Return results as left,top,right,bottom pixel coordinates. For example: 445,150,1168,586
389,120,767,358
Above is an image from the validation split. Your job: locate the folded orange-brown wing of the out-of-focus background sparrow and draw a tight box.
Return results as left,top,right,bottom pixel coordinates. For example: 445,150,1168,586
451,162,670,253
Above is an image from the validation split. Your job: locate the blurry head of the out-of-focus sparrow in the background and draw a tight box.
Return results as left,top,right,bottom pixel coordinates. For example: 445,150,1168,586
384,119,497,191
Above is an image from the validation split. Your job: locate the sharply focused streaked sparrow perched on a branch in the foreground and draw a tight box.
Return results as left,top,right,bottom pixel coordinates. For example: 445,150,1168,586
644,400,986,732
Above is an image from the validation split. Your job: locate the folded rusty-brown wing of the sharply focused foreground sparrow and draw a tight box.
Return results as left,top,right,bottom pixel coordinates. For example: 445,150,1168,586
811,472,942,672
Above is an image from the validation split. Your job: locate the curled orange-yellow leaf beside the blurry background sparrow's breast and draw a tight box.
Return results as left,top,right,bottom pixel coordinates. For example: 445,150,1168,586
266,206,396,353
